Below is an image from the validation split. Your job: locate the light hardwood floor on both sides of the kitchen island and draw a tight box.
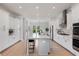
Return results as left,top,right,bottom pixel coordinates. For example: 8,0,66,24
0,41,73,56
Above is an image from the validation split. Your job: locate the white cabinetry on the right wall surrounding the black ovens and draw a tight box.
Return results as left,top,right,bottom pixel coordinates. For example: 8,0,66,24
54,4,79,55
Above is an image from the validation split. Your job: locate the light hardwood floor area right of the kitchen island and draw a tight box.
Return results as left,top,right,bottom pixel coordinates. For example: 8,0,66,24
49,41,73,56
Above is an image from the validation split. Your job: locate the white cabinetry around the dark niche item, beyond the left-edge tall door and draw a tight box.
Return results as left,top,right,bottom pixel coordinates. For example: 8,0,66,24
9,16,21,43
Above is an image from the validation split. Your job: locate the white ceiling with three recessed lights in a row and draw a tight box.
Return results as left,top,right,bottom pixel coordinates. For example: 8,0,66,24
1,3,73,18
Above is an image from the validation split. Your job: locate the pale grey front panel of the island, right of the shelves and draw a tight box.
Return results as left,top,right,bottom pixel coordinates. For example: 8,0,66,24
38,39,50,55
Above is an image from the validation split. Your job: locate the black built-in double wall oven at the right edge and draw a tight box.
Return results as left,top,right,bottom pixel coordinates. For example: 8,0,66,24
73,23,79,51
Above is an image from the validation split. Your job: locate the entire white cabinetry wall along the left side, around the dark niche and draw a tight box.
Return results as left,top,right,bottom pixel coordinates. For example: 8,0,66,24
0,9,20,52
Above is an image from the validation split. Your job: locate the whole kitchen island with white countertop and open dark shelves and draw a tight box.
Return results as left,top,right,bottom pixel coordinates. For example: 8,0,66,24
27,35,50,56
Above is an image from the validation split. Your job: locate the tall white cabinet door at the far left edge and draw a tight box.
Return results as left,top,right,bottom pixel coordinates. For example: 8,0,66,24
0,10,8,51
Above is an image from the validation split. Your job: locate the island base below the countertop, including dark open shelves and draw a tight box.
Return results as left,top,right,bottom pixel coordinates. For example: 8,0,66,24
27,38,50,56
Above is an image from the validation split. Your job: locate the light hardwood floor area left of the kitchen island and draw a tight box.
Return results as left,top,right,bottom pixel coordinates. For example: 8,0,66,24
0,41,26,56
